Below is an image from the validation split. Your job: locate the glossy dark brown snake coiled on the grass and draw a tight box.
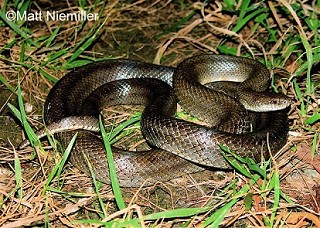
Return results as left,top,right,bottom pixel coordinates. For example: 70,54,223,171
20,55,290,187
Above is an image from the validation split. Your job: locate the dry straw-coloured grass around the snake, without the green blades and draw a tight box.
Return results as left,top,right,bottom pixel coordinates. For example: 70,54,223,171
0,0,320,227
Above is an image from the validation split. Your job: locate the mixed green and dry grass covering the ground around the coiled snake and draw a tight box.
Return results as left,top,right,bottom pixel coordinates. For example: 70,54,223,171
0,0,320,227
